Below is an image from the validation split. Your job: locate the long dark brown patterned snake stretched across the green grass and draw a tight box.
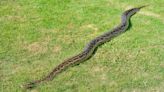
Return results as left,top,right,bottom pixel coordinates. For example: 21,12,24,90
21,5,147,89
